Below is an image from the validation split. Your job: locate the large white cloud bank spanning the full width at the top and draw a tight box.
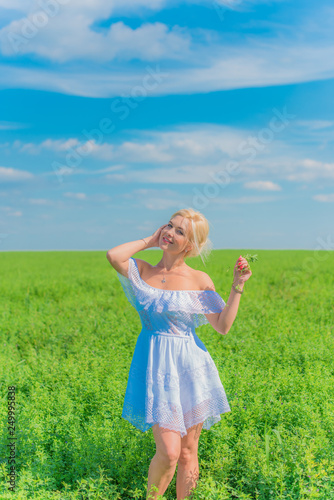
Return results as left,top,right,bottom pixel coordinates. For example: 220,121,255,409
0,4,334,96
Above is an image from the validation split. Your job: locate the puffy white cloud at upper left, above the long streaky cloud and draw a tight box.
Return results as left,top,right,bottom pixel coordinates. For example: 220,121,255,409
0,12,191,63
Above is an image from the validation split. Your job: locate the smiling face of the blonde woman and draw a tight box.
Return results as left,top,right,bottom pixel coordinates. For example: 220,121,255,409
159,215,189,253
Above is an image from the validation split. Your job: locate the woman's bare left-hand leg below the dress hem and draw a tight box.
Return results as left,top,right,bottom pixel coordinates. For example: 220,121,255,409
146,424,181,500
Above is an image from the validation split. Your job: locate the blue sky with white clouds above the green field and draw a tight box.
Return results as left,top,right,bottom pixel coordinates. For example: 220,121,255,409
0,0,334,250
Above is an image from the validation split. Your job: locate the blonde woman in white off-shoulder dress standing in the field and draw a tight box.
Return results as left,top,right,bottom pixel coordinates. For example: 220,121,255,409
107,209,252,500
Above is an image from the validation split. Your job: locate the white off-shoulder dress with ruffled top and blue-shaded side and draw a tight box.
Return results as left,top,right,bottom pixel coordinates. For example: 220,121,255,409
117,257,231,437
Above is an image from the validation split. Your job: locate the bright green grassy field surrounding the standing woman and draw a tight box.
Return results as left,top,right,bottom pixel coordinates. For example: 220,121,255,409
0,250,334,500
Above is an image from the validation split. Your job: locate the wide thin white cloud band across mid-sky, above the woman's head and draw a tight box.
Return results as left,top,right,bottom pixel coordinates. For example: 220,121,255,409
6,123,334,186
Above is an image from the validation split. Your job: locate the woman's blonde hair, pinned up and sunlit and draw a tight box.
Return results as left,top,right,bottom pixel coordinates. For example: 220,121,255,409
171,208,212,265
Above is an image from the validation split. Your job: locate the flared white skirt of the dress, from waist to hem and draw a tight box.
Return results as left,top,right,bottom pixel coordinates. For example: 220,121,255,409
122,328,231,437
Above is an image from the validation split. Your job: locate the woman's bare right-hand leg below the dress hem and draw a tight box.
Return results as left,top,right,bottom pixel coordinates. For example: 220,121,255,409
176,422,203,500
